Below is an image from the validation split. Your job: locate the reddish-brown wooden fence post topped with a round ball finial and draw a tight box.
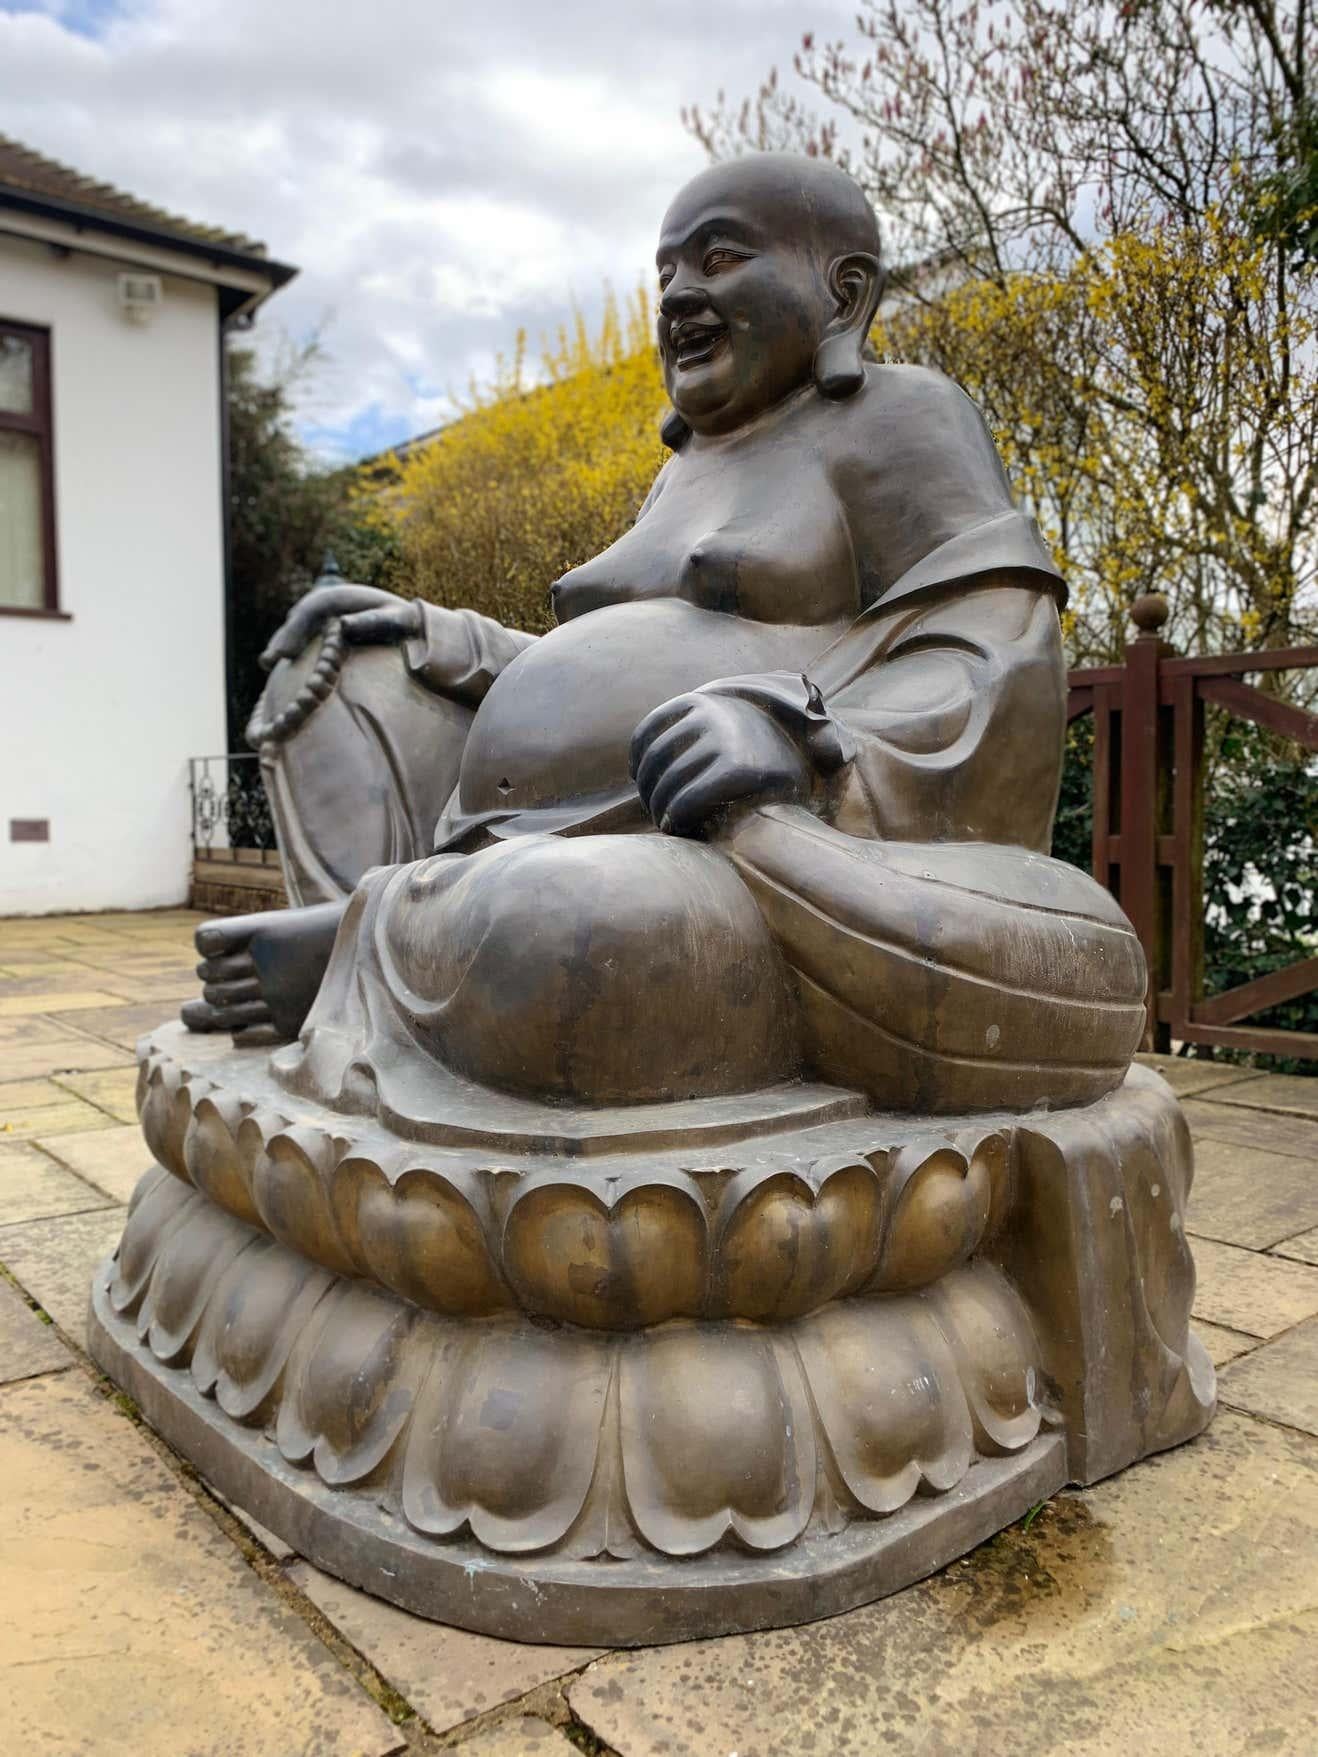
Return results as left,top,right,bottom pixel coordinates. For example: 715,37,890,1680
1118,592,1172,1051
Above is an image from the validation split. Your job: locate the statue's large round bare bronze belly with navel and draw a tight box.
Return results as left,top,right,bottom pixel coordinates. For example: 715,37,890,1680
459,597,836,812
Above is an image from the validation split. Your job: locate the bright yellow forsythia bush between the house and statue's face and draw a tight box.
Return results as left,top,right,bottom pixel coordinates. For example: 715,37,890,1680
374,292,666,631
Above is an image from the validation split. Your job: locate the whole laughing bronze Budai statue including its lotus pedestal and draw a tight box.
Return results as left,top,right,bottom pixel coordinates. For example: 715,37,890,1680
93,155,1213,1643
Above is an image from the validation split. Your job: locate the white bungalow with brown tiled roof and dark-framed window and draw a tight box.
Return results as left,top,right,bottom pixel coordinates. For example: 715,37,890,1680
0,137,297,915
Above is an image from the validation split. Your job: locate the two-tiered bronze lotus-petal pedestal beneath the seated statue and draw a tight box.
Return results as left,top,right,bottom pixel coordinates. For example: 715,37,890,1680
90,1030,1213,1646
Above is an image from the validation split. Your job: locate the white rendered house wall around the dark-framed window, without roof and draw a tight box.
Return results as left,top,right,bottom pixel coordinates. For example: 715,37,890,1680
0,237,225,915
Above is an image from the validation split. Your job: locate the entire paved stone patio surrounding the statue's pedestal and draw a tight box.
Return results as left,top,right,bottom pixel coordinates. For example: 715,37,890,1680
0,910,1318,1757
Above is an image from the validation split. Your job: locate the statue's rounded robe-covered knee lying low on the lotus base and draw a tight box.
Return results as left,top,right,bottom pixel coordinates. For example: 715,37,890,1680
388,836,798,1105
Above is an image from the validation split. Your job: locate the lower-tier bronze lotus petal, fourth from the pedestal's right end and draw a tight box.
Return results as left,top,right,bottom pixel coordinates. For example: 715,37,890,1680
402,1318,615,1553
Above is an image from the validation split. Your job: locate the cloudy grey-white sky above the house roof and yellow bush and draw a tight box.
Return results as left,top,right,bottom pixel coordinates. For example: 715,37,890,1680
0,0,854,457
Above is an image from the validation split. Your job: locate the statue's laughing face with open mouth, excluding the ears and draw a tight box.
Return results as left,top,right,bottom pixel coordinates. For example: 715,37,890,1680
655,160,836,434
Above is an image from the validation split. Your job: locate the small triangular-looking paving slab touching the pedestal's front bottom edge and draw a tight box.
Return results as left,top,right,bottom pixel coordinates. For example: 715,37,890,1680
290,1562,599,1732
